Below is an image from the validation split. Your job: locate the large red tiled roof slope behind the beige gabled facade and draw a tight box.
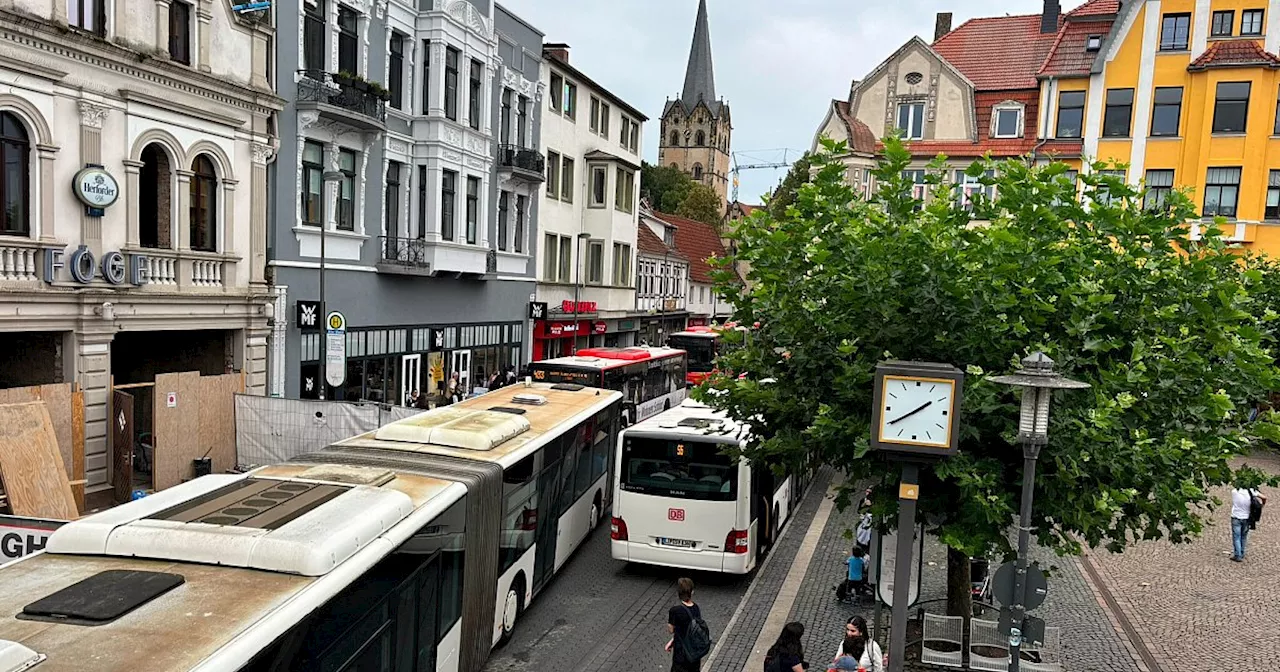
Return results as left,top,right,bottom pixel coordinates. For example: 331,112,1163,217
933,14,1057,91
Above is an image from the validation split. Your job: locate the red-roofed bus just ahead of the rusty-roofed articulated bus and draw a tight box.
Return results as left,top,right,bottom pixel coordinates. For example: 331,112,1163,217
529,347,689,426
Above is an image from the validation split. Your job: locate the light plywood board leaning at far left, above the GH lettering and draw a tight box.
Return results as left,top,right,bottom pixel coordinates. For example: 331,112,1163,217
0,402,79,520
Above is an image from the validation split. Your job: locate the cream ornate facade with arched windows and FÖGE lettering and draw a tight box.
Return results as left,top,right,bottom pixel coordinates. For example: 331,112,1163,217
0,0,282,493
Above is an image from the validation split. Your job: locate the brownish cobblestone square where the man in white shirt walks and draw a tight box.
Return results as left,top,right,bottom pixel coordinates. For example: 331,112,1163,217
1088,454,1280,672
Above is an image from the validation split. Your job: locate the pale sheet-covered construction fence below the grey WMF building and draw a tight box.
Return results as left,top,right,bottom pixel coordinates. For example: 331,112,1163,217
236,394,422,467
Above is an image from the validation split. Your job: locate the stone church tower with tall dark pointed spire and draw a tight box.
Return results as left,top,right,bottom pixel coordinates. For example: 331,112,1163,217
658,0,733,201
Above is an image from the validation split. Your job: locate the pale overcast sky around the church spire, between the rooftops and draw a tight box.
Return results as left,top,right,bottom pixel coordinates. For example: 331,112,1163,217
499,0,1083,202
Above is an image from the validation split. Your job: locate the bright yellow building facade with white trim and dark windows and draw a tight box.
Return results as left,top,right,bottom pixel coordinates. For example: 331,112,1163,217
1085,0,1280,250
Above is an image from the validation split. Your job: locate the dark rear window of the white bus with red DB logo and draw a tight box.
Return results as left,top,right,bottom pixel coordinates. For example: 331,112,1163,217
618,438,737,502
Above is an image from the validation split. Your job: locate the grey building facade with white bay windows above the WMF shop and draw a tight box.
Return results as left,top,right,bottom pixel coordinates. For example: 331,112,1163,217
270,0,544,403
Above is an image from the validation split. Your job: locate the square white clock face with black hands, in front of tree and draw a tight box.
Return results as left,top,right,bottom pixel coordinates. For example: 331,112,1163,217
879,375,956,447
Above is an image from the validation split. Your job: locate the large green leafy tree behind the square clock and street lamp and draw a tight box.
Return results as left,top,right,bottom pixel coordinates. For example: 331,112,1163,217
696,138,1276,614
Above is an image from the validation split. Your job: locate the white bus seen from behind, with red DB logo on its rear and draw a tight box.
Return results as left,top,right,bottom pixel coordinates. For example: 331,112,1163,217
611,401,804,573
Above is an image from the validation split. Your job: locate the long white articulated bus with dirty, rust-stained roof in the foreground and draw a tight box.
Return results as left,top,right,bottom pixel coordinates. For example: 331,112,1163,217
0,384,622,672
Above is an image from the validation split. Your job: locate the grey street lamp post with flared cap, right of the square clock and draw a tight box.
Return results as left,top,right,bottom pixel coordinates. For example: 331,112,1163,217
989,352,1089,672
